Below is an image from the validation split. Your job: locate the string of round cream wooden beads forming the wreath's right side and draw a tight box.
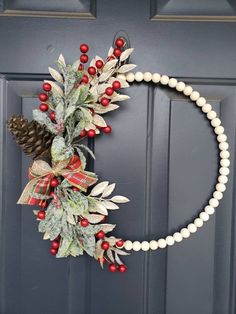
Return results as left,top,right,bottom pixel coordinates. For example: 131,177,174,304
124,72,230,252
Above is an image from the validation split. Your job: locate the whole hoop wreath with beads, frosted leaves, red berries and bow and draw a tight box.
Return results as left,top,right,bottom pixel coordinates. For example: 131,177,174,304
7,38,230,273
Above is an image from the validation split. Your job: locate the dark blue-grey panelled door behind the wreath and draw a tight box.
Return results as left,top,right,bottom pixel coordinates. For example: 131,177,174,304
0,0,236,314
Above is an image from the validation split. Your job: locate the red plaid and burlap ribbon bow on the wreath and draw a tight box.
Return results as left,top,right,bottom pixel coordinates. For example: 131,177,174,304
17,155,97,205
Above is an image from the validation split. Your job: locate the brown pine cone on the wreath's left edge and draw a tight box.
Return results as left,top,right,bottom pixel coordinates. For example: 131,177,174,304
7,115,54,159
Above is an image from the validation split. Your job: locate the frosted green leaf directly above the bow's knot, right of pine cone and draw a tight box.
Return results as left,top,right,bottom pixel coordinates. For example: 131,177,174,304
51,136,74,162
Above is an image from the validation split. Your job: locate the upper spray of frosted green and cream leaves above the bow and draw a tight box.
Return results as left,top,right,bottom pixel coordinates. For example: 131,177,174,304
33,47,136,144
